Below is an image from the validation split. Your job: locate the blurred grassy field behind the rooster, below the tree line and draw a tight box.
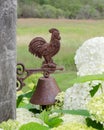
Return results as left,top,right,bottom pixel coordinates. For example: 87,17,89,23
17,19,104,90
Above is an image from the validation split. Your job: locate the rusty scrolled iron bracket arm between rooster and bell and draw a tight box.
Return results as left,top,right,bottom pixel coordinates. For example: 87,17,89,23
17,63,63,91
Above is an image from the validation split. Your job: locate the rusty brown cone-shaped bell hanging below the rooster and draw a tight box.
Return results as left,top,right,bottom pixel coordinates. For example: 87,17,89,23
30,77,60,105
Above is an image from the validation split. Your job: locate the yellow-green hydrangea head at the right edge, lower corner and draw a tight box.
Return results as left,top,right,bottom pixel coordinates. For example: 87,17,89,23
87,93,104,125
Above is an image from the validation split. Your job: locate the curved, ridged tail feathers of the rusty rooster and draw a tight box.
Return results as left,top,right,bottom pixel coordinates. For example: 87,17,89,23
29,37,46,58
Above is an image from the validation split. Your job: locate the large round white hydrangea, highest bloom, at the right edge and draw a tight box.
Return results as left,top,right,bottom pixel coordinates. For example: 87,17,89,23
75,37,104,76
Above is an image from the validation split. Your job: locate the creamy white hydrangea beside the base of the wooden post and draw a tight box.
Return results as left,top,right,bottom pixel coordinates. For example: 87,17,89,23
16,108,44,125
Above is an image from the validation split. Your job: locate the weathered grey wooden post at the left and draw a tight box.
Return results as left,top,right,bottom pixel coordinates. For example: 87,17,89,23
0,0,17,122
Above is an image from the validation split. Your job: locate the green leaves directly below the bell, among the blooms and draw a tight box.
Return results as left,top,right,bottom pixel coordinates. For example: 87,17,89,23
39,110,62,128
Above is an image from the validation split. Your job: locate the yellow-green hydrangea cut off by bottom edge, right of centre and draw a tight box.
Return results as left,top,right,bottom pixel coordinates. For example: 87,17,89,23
52,123,96,130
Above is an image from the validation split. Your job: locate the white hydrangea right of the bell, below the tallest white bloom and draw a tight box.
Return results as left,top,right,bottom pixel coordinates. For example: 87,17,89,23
63,82,92,109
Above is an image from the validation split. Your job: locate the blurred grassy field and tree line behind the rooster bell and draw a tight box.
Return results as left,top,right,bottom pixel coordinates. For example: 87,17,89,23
17,0,104,90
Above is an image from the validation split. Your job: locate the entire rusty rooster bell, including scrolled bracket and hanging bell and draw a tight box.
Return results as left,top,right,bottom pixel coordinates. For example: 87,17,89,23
17,28,63,106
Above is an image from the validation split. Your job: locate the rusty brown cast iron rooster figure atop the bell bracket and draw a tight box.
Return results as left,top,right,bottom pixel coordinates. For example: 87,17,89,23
29,28,61,68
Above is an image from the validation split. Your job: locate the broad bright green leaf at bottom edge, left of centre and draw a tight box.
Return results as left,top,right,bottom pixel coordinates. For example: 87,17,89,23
19,122,49,130
